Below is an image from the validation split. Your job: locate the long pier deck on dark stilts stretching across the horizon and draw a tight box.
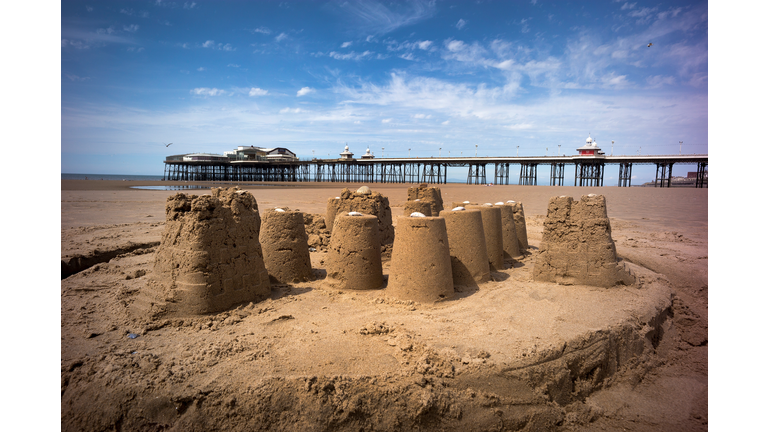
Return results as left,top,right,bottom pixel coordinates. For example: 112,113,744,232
163,155,709,188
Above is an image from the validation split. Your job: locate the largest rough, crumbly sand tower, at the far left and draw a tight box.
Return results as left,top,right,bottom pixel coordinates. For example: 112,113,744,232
147,188,270,315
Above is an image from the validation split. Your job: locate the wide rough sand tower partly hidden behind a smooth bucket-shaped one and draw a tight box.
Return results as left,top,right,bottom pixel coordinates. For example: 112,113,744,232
325,186,395,245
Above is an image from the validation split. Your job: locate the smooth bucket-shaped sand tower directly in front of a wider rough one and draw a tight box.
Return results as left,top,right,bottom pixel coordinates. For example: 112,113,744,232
326,212,384,290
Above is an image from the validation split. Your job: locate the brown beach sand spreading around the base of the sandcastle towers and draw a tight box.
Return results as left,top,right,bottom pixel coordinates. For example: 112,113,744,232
61,180,708,431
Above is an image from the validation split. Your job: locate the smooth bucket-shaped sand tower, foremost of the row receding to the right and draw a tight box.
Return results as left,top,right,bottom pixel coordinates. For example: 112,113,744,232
387,216,453,303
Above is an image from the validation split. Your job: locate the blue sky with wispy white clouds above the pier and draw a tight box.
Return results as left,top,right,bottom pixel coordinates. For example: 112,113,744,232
61,0,709,185
